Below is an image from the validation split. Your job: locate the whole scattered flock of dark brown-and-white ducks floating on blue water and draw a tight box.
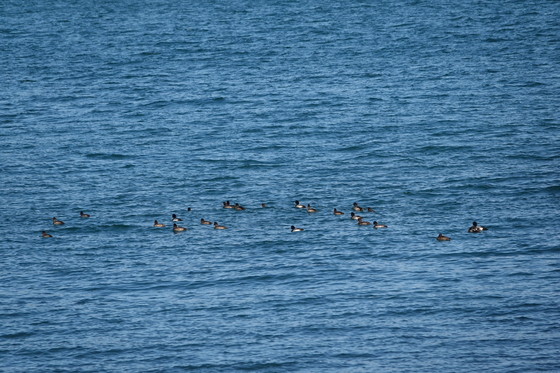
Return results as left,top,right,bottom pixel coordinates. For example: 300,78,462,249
42,201,488,241
